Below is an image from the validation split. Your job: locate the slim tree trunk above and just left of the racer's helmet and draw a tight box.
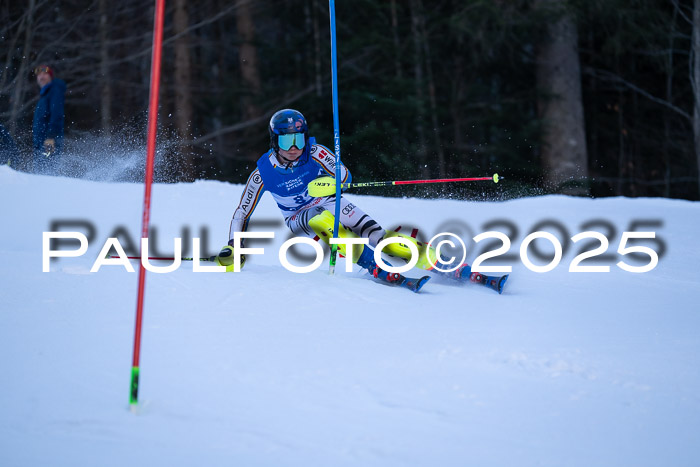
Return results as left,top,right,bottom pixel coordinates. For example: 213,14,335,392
236,2,262,120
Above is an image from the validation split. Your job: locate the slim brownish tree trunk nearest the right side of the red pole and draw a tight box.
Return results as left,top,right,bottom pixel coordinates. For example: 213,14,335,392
173,0,195,181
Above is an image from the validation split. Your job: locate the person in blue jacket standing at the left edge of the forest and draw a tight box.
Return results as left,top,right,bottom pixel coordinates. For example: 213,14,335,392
32,65,66,174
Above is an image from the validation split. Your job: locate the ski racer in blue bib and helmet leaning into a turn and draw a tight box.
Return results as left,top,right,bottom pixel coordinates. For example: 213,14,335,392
216,109,504,291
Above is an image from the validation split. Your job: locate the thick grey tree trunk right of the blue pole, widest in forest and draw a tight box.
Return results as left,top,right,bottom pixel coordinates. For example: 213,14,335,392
537,0,588,194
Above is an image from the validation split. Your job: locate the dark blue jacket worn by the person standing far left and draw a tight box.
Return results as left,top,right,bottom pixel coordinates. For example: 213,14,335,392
32,79,66,149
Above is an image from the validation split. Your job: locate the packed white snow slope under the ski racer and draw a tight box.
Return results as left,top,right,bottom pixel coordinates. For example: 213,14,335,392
0,168,700,467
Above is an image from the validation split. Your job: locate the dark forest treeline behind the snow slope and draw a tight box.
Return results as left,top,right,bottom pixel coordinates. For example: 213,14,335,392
0,0,700,199
